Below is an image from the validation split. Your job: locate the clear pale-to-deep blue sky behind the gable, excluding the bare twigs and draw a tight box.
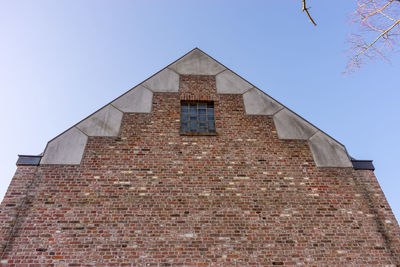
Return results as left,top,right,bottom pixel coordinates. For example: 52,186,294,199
0,0,400,219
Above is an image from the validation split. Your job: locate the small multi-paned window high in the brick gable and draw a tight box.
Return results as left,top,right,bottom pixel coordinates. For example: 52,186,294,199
181,101,216,134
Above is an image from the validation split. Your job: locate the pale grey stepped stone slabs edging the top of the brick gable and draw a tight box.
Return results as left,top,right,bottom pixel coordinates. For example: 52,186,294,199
37,48,352,167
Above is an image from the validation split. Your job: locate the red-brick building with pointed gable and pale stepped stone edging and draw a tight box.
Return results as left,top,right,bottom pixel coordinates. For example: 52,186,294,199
0,49,400,266
